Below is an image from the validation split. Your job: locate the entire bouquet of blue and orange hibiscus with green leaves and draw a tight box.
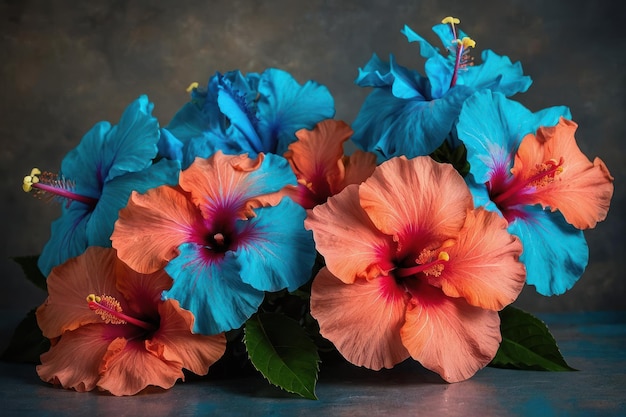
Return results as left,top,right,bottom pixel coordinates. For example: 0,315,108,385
5,17,613,398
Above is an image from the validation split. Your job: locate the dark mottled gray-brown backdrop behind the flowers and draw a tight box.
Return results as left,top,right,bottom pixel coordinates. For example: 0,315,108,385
0,0,626,322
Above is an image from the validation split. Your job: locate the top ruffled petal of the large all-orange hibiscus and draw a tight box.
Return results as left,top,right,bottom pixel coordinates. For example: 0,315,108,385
359,156,473,240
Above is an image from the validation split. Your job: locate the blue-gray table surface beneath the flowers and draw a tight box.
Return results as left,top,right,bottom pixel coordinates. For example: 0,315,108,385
0,312,626,417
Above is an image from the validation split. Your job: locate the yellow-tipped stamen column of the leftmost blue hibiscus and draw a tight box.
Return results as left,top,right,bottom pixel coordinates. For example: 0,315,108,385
22,168,98,208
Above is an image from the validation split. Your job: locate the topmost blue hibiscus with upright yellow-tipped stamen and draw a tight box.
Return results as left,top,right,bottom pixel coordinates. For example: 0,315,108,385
352,18,531,161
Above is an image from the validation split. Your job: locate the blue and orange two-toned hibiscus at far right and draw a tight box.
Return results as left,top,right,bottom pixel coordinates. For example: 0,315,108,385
457,91,613,295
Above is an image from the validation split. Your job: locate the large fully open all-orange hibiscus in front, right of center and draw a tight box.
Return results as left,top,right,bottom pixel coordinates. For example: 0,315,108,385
305,157,525,382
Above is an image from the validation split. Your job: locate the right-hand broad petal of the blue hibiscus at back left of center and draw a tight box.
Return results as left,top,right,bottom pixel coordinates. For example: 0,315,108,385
257,68,335,155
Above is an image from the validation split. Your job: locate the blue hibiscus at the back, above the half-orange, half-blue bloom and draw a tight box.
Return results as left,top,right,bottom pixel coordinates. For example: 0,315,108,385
161,68,335,167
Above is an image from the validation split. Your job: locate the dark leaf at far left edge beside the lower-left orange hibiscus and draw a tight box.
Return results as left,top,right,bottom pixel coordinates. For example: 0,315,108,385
1,309,50,363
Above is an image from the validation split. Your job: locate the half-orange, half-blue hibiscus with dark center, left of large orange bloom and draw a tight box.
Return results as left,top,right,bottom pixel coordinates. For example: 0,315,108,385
111,151,315,334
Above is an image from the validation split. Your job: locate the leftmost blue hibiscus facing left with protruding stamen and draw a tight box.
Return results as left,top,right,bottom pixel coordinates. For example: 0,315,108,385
24,96,180,275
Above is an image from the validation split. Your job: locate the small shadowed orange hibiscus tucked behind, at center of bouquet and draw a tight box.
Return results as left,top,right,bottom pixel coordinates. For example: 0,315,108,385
284,119,376,209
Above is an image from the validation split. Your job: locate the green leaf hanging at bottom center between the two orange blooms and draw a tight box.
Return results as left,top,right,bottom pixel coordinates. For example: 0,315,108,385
244,313,320,400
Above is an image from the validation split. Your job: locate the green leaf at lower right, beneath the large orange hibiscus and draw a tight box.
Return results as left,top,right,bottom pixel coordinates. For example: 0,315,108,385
490,306,576,371
